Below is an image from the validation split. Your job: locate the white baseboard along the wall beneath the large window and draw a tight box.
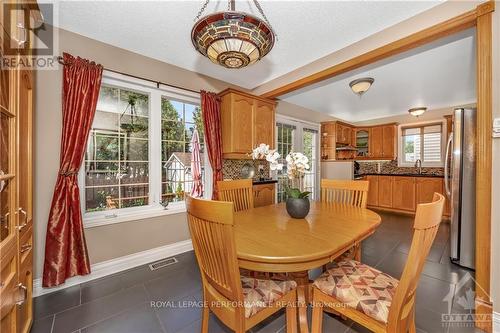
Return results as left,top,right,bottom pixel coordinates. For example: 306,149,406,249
33,239,193,297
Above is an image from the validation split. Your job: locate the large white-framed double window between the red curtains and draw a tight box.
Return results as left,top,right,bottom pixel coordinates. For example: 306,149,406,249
80,76,204,218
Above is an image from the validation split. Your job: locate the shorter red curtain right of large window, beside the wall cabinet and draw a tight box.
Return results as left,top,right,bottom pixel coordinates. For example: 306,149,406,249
201,91,223,200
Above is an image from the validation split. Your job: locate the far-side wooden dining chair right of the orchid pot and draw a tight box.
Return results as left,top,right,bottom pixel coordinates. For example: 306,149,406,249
321,179,370,262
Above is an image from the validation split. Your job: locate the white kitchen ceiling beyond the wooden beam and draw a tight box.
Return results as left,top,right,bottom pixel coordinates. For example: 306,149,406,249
280,29,476,122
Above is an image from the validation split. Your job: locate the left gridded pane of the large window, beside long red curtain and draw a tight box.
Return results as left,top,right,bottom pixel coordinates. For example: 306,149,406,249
85,85,149,212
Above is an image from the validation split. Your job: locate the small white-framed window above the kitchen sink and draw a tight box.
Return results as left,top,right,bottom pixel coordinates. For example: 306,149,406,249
399,122,444,167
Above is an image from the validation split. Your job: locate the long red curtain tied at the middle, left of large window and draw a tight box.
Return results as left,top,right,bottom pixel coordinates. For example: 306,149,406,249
43,53,103,287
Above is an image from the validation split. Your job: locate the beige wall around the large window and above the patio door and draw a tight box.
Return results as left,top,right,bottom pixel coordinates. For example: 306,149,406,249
35,30,321,278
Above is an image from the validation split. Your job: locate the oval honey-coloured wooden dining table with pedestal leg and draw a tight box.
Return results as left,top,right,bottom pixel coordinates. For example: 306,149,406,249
234,201,381,332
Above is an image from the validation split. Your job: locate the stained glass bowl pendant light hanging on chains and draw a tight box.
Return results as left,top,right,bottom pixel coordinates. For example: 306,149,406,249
191,0,276,68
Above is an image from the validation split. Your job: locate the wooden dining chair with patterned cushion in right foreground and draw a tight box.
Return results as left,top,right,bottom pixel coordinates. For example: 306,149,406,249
312,193,444,333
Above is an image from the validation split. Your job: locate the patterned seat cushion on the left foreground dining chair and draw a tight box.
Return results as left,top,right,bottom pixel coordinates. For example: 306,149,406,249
241,276,297,318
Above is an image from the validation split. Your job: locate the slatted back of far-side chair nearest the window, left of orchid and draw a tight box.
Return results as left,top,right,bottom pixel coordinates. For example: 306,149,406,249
217,179,253,212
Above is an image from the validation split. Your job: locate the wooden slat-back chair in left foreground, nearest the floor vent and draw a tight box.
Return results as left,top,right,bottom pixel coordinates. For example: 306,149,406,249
186,196,297,333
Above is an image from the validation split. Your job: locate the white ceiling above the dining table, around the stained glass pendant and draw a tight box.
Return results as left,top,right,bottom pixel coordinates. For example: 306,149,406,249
45,0,439,89
